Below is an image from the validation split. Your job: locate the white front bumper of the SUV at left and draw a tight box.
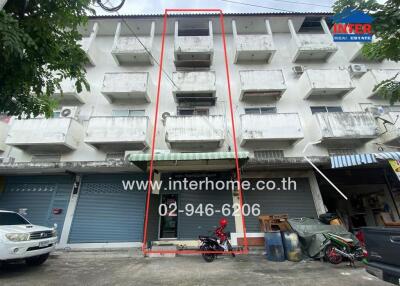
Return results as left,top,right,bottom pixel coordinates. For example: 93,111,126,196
0,237,57,261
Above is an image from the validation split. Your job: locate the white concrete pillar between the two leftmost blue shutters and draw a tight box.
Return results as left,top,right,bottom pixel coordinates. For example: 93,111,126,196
57,175,81,248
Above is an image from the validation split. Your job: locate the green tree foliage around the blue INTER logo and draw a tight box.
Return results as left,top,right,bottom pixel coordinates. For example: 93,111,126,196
333,0,400,104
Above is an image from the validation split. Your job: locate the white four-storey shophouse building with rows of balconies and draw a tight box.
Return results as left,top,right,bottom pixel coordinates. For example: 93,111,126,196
0,13,400,247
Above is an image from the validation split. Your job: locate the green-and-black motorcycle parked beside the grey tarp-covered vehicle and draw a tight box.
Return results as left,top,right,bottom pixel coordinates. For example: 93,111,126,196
322,232,366,266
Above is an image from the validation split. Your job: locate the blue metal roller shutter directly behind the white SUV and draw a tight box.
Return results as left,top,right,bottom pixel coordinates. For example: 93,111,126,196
0,176,73,234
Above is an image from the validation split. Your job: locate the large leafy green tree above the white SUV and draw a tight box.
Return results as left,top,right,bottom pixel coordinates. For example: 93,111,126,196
0,0,93,117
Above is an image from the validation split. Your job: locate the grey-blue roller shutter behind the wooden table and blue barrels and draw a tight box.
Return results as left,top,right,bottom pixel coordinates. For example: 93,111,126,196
243,178,317,232
